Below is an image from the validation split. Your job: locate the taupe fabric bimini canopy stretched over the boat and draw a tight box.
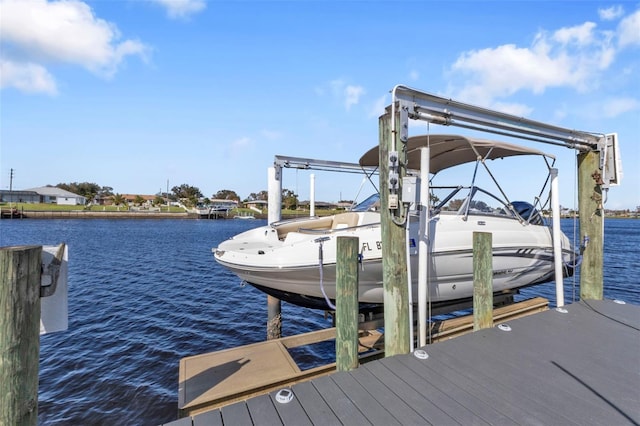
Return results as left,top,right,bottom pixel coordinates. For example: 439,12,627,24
359,135,555,174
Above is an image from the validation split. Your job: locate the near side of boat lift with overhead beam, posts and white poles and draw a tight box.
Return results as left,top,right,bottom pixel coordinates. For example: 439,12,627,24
380,85,622,355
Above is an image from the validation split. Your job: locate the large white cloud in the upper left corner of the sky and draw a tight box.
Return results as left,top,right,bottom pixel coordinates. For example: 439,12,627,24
0,0,149,93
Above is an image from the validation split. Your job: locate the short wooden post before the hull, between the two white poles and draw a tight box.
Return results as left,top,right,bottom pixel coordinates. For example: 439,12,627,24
473,232,493,331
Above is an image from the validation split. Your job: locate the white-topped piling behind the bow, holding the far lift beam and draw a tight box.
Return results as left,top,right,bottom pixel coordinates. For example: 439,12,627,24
267,166,282,340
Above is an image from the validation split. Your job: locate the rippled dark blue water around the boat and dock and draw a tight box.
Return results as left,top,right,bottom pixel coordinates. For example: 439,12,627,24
0,219,640,425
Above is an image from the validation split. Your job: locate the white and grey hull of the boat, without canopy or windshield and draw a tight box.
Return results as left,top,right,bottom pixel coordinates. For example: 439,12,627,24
214,214,573,306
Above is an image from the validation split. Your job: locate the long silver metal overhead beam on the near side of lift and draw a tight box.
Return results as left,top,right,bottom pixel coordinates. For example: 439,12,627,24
391,85,606,151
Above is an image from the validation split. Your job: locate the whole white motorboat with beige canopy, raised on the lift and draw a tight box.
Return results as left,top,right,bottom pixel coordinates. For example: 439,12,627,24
212,135,575,309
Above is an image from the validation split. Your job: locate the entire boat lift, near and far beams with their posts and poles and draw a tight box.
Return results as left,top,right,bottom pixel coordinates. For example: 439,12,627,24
267,85,622,354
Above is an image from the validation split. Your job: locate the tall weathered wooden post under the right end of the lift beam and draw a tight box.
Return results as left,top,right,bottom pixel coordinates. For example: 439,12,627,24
578,151,604,300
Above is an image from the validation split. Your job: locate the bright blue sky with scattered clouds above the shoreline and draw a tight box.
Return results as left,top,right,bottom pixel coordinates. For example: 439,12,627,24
0,0,640,209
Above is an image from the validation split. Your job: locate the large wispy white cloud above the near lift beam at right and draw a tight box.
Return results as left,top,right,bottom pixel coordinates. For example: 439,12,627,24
444,13,640,106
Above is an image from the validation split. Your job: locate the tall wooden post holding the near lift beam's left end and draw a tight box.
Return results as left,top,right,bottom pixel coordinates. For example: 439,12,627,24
379,113,413,356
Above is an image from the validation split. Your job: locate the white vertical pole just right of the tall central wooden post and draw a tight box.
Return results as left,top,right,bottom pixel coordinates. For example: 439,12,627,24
418,147,430,347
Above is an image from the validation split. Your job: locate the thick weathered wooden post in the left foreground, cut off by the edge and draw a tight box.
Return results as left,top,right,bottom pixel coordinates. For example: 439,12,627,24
0,246,42,425
